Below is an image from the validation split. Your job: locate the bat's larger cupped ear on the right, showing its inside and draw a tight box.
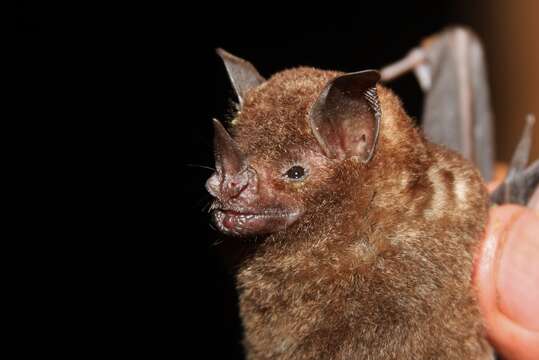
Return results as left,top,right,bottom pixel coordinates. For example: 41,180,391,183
309,70,381,162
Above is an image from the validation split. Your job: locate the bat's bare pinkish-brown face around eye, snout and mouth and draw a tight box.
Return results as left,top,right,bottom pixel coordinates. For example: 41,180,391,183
206,131,330,236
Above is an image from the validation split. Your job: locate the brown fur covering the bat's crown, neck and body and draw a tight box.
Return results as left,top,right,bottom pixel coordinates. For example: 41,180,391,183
220,68,491,359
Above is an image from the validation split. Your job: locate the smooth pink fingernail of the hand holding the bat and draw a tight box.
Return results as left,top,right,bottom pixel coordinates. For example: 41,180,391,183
496,211,539,331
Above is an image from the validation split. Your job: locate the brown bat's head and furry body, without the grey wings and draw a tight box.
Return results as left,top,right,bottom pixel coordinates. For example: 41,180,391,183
206,34,535,359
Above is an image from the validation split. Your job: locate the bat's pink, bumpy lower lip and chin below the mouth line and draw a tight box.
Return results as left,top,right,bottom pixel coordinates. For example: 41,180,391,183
213,209,300,236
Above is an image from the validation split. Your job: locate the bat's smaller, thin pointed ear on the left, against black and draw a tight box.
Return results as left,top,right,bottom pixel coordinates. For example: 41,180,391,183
216,49,266,105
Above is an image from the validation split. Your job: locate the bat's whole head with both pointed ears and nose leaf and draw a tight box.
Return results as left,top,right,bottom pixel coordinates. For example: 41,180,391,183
206,50,381,236
